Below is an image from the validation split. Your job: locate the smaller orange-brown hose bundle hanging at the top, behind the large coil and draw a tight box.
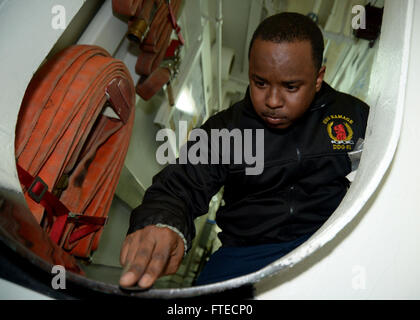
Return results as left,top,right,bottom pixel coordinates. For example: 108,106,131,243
112,0,184,105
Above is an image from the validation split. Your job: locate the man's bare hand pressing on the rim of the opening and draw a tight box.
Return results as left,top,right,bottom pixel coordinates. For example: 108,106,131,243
120,225,184,288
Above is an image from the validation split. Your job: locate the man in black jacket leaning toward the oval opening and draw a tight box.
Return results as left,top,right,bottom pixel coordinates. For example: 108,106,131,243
120,13,369,288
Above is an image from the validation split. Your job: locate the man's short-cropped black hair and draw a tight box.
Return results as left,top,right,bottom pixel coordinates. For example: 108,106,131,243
248,12,324,70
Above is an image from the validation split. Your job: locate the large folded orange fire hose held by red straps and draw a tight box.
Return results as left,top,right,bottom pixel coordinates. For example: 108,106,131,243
15,45,135,257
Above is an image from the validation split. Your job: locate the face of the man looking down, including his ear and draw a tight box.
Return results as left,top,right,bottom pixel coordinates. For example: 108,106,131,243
249,38,325,129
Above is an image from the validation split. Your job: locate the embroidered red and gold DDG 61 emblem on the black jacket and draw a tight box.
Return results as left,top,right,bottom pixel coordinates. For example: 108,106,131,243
322,114,354,150
